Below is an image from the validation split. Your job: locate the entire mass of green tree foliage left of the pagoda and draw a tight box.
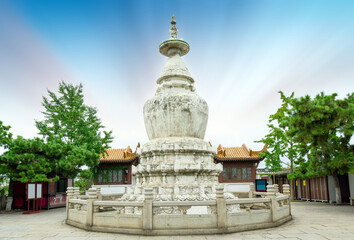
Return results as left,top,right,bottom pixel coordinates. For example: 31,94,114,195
0,82,112,182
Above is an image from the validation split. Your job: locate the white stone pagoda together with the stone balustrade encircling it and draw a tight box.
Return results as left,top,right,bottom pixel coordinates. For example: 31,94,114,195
66,17,292,235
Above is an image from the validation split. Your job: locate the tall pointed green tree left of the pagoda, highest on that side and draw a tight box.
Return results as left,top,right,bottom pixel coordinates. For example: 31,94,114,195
36,82,112,178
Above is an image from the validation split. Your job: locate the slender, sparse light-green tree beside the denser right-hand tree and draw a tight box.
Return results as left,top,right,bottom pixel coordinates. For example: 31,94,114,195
257,91,299,198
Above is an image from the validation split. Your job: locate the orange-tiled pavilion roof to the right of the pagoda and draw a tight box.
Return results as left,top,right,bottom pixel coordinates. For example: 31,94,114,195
215,144,268,161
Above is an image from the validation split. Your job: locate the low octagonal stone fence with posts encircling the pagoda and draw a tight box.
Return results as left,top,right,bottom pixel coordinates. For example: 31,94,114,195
66,185,291,235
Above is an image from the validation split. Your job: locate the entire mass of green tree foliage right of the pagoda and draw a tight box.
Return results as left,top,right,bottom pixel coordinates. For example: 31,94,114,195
260,92,354,203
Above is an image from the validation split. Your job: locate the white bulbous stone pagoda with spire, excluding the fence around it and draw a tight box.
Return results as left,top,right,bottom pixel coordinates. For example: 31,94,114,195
121,16,234,201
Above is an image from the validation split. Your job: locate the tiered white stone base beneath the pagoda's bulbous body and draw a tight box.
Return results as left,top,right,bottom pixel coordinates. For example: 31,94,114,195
121,137,235,201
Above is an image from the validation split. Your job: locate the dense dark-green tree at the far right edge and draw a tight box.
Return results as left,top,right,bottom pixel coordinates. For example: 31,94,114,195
289,93,354,203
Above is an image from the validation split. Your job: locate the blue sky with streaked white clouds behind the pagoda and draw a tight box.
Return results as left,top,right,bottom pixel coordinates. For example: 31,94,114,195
0,0,354,165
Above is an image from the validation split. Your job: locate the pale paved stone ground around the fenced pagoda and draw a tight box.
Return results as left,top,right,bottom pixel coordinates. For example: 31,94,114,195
0,202,354,240
